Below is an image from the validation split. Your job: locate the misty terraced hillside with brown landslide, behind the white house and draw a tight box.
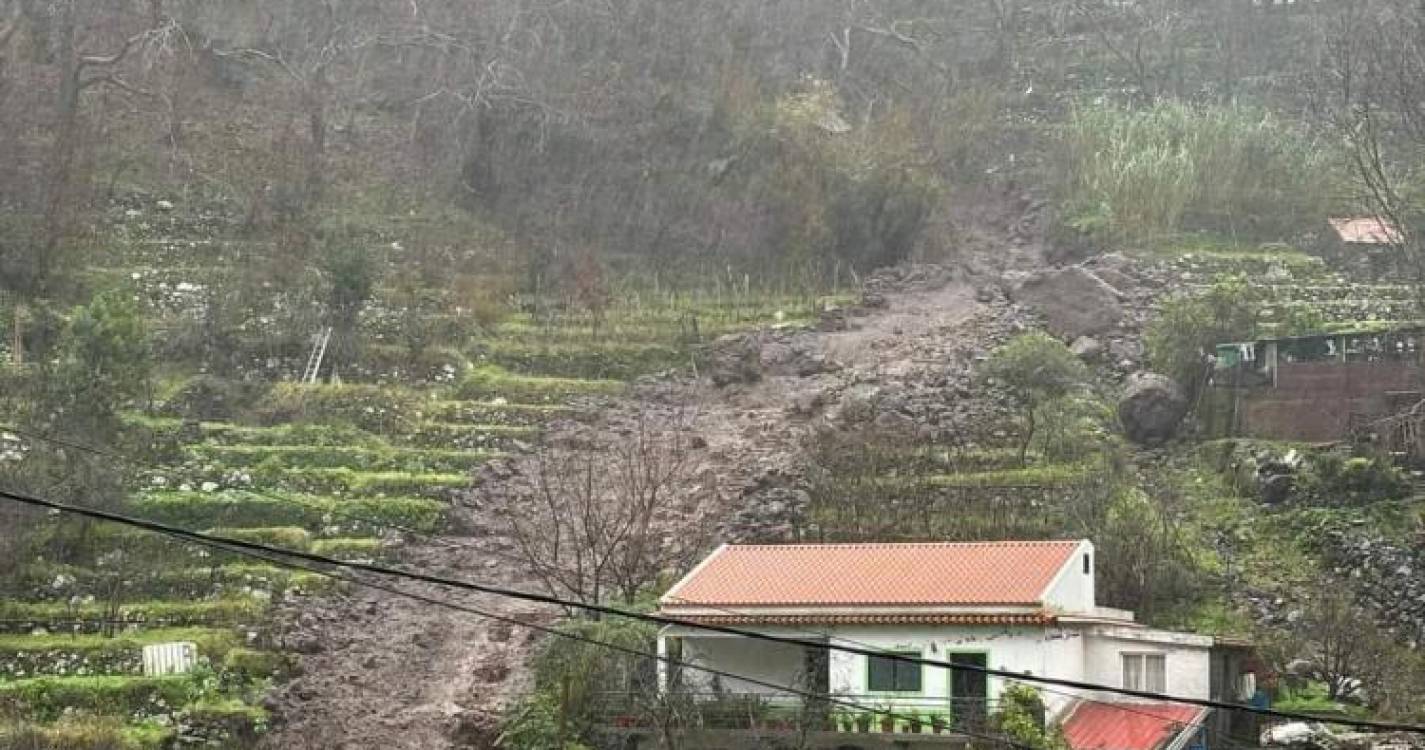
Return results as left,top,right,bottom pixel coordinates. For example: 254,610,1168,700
0,0,1425,750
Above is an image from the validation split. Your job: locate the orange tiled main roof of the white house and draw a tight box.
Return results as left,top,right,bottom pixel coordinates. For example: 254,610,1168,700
663,542,1079,606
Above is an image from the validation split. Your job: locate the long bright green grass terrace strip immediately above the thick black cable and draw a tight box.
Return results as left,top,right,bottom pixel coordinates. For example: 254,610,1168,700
131,493,444,533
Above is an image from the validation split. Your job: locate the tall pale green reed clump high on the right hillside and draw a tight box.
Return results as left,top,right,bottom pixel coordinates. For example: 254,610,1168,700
1060,101,1334,242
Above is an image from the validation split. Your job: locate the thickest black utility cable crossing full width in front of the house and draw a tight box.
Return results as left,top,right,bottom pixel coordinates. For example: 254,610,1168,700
0,490,1425,734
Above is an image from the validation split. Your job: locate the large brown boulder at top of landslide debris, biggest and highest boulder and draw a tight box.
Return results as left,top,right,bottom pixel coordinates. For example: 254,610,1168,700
1010,265,1123,341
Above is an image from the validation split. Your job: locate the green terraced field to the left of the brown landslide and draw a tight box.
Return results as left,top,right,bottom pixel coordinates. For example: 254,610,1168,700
0,192,844,750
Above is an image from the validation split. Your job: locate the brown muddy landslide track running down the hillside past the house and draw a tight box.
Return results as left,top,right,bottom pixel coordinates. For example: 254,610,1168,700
256,268,998,750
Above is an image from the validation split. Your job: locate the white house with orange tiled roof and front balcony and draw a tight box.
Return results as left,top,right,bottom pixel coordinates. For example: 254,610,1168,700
658,540,1231,750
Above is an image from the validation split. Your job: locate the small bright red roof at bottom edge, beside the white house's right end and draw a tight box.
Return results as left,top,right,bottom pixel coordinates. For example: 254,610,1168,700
1063,702,1207,750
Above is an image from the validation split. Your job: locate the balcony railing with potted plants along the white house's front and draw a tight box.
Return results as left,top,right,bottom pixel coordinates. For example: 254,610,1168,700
603,692,998,734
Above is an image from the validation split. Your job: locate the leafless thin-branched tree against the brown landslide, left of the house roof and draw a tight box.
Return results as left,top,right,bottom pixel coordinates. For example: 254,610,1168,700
497,409,710,602
